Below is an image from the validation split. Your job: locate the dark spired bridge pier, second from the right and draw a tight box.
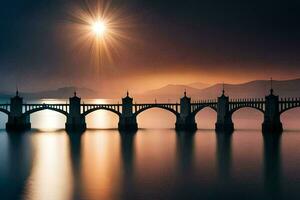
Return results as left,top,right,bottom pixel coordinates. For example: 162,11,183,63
215,90,234,133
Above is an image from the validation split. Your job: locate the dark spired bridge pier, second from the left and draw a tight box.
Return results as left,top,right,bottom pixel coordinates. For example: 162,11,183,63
65,93,86,132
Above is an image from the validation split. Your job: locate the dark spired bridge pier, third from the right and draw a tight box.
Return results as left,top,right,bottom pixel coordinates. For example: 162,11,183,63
175,92,197,131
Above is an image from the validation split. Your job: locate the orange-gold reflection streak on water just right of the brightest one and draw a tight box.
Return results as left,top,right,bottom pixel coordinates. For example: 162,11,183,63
82,130,121,199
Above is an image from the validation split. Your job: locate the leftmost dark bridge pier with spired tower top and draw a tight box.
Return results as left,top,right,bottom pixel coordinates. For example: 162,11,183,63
6,91,31,131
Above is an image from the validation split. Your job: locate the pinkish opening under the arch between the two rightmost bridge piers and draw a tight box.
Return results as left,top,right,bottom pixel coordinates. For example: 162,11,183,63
231,106,264,130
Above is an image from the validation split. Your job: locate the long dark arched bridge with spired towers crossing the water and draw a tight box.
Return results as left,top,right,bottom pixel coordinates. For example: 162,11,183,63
0,88,300,133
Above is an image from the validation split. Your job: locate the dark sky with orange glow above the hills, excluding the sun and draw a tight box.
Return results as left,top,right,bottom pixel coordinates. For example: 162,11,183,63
0,0,300,92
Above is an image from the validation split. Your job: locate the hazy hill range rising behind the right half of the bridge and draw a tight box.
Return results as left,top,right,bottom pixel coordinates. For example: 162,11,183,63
138,79,300,101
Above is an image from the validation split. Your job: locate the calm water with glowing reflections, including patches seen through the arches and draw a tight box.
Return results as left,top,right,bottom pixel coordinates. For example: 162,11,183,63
0,99,300,200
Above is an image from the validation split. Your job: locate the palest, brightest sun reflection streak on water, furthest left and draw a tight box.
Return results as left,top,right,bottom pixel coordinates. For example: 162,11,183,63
25,132,73,200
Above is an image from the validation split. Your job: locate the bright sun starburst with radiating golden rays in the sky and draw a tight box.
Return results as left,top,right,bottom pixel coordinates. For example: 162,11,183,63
70,1,131,69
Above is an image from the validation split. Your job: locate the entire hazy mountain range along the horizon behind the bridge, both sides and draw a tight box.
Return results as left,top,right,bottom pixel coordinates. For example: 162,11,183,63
0,79,300,101
